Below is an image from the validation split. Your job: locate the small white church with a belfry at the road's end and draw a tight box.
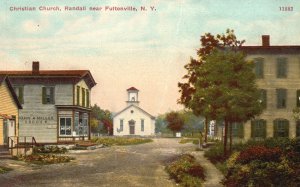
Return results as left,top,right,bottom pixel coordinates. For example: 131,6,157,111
113,87,155,136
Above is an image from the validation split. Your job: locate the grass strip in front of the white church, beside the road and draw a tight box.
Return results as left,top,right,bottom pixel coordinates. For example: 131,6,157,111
92,137,153,146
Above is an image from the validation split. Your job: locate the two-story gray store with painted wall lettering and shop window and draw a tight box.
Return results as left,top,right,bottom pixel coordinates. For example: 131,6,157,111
0,62,96,143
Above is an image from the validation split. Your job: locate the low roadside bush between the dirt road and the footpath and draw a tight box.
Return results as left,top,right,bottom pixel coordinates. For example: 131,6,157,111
165,154,205,187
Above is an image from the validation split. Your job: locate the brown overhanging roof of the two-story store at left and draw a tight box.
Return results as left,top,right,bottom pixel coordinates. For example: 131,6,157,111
0,70,97,88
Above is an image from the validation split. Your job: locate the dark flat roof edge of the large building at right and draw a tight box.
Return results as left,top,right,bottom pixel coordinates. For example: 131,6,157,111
240,45,300,54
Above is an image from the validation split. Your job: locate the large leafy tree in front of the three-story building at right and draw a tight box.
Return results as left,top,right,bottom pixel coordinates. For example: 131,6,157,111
178,30,262,155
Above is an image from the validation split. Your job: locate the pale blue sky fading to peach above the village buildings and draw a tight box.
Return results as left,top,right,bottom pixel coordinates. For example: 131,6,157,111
0,0,300,115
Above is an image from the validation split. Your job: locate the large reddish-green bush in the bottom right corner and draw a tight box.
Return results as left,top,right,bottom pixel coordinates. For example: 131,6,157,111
222,146,300,186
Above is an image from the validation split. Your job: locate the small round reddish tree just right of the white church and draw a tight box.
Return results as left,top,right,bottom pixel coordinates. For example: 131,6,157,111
166,111,184,135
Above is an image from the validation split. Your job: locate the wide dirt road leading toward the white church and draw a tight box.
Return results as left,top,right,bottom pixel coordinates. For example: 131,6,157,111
0,139,202,187
